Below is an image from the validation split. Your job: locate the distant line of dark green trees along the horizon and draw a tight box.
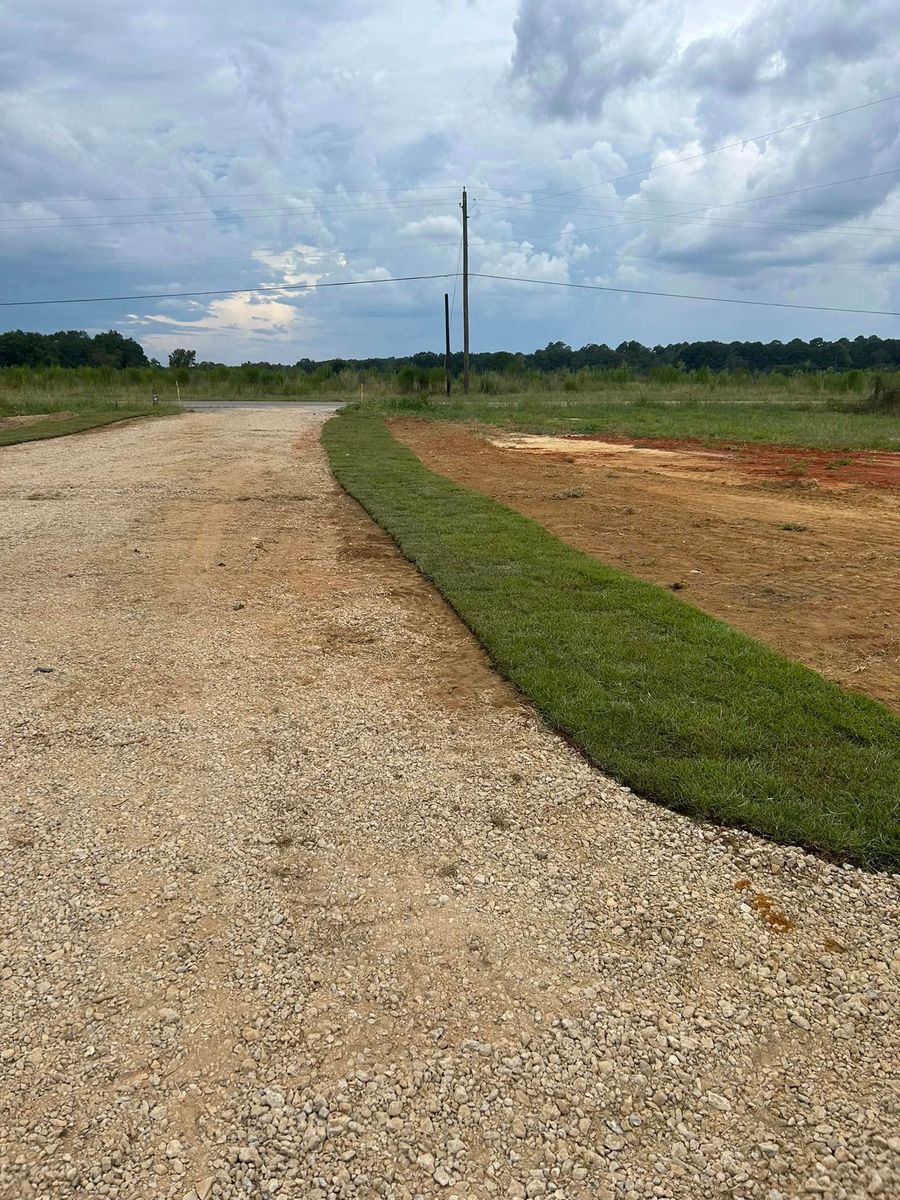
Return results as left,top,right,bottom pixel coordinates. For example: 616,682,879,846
0,329,900,376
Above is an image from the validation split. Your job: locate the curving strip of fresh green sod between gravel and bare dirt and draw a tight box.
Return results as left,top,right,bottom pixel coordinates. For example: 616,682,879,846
323,412,900,870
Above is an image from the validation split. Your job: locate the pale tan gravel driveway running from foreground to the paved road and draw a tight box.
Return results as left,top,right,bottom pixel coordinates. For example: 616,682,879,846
0,409,900,1200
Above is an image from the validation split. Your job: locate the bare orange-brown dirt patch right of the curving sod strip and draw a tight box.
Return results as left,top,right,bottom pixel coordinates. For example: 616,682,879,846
392,420,900,712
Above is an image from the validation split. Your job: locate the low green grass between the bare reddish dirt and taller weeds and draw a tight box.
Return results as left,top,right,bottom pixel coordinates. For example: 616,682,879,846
364,383,900,450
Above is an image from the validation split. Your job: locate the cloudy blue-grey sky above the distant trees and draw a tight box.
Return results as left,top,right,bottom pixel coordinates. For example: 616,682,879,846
0,0,900,362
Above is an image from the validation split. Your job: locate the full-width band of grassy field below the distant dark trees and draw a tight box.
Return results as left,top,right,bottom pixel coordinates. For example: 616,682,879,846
0,365,900,450
